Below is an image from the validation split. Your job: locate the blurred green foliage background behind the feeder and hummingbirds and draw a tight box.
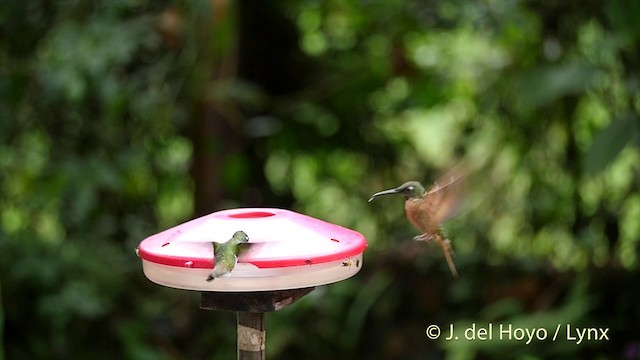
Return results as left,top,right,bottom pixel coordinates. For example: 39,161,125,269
0,0,640,359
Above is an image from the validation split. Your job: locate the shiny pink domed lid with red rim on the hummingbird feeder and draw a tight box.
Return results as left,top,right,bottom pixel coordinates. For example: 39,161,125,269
138,208,367,269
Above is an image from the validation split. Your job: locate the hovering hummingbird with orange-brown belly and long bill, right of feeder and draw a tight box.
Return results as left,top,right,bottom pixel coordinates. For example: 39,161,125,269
369,171,465,278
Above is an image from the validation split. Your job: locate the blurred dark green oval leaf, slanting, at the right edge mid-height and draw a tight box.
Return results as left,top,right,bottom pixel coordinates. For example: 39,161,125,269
583,114,640,174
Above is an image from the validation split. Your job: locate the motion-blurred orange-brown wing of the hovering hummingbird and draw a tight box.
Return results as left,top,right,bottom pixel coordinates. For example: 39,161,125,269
425,168,467,223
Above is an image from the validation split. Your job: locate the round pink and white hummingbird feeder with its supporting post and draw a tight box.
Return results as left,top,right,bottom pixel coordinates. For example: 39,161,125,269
136,208,367,358
